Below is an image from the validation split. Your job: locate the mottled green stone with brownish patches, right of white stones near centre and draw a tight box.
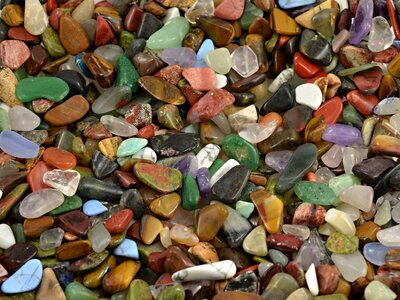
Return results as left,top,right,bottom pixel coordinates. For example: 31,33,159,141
222,134,260,170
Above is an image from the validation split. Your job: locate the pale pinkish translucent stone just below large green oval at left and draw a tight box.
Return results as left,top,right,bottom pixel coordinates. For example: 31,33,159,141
8,105,40,131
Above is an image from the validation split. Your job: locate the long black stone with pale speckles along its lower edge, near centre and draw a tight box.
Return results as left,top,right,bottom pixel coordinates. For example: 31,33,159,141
149,133,200,156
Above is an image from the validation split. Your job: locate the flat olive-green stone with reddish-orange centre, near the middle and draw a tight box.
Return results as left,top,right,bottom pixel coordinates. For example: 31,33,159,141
133,162,182,193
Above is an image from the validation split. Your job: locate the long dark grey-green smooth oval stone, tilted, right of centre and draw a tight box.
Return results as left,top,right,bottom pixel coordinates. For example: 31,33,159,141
275,143,317,194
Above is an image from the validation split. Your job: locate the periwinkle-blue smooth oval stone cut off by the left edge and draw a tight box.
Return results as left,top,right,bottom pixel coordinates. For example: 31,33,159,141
0,130,39,158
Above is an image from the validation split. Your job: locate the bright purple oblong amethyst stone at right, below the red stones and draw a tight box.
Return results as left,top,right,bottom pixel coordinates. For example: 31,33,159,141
322,124,361,146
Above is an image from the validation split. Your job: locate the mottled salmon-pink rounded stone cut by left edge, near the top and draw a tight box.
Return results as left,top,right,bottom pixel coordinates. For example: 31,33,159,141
0,40,31,70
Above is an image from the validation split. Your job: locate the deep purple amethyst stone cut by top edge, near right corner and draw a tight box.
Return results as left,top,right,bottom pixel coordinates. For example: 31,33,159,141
349,0,374,45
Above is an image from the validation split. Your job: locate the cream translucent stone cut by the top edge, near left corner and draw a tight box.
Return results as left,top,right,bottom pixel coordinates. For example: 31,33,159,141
24,0,49,35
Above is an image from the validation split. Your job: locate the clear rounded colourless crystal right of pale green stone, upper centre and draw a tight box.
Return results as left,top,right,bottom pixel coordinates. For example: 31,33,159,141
232,46,259,78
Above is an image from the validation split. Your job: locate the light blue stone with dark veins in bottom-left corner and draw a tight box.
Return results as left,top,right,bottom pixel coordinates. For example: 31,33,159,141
1,259,43,294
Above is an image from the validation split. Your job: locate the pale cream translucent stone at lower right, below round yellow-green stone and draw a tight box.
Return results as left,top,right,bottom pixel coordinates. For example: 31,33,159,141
332,251,367,282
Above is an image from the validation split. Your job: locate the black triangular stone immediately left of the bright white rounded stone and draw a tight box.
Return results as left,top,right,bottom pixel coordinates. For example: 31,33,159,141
260,83,294,115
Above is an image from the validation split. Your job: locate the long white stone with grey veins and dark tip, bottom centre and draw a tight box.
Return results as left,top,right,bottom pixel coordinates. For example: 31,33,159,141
172,260,236,282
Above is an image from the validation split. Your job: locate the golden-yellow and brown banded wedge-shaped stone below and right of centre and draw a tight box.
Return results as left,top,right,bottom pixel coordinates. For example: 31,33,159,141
250,190,284,233
